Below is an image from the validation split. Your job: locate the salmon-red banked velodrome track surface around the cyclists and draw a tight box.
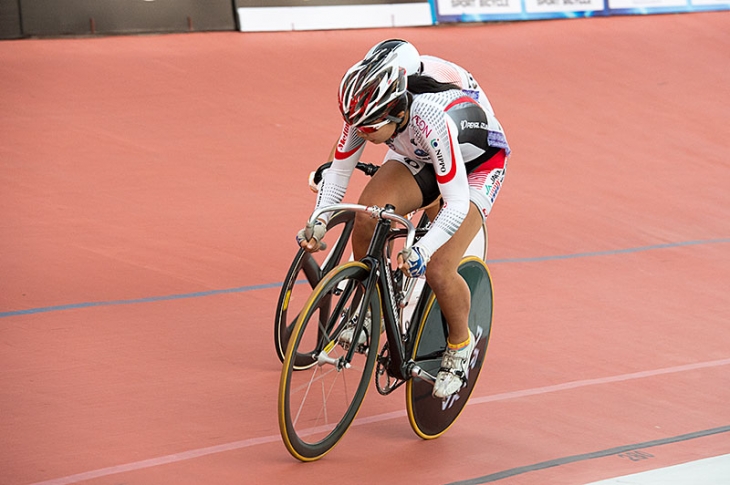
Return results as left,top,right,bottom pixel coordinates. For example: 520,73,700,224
0,12,730,485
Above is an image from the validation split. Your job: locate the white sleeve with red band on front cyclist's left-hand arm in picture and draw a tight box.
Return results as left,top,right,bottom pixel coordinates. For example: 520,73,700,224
315,123,365,222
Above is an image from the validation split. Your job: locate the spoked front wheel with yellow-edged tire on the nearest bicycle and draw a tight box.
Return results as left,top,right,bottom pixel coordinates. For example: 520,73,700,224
278,262,381,461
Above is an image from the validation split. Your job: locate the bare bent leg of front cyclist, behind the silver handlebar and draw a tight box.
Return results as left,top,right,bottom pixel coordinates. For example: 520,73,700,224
352,157,422,259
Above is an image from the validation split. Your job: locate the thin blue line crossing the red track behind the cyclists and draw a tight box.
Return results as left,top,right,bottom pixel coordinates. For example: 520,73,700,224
0,238,730,318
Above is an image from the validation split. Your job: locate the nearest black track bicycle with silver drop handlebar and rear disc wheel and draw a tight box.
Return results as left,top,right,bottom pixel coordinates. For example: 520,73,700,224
278,204,492,461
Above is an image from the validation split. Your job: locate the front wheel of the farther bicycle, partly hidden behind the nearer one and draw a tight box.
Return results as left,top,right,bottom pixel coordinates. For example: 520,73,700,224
274,211,355,367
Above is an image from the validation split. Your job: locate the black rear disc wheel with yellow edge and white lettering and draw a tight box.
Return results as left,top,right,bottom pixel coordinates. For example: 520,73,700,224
406,256,494,440
